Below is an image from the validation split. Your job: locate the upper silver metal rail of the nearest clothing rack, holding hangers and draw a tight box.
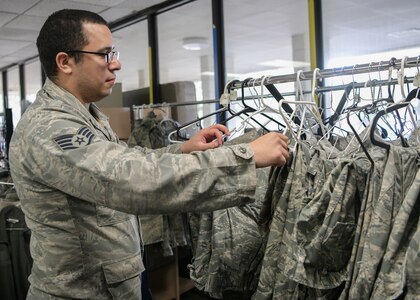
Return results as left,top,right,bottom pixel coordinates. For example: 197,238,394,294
230,55,420,89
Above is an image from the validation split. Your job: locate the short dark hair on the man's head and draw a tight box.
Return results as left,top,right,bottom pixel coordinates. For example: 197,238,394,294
36,9,108,80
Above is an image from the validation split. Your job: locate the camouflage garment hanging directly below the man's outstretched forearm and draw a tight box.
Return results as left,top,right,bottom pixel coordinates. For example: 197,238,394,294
189,131,270,299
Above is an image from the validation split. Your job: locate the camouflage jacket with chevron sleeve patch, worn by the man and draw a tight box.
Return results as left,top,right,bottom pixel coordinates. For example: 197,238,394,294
10,79,256,299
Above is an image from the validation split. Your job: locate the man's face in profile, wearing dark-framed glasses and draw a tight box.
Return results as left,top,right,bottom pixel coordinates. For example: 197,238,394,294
73,23,121,103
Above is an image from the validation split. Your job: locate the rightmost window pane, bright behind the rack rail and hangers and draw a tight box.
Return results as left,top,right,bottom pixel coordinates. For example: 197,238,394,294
322,0,420,130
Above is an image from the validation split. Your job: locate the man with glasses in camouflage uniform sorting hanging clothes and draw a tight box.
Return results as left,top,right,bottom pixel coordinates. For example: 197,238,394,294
10,10,288,299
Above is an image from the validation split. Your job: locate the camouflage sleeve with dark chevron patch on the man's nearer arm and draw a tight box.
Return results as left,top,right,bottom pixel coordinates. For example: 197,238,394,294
17,118,256,214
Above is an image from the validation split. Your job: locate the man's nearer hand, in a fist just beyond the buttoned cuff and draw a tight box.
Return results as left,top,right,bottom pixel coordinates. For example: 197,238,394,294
249,132,289,168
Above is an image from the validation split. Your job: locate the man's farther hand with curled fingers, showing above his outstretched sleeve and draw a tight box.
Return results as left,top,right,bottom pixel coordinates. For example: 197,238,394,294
181,124,230,153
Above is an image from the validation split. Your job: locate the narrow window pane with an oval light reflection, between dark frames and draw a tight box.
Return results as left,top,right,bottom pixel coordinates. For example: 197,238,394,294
157,0,215,127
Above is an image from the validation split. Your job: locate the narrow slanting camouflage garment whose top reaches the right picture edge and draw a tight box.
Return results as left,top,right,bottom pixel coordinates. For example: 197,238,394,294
350,146,418,299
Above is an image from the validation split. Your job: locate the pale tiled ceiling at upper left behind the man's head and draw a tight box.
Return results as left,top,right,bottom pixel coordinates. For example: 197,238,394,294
0,0,170,69
